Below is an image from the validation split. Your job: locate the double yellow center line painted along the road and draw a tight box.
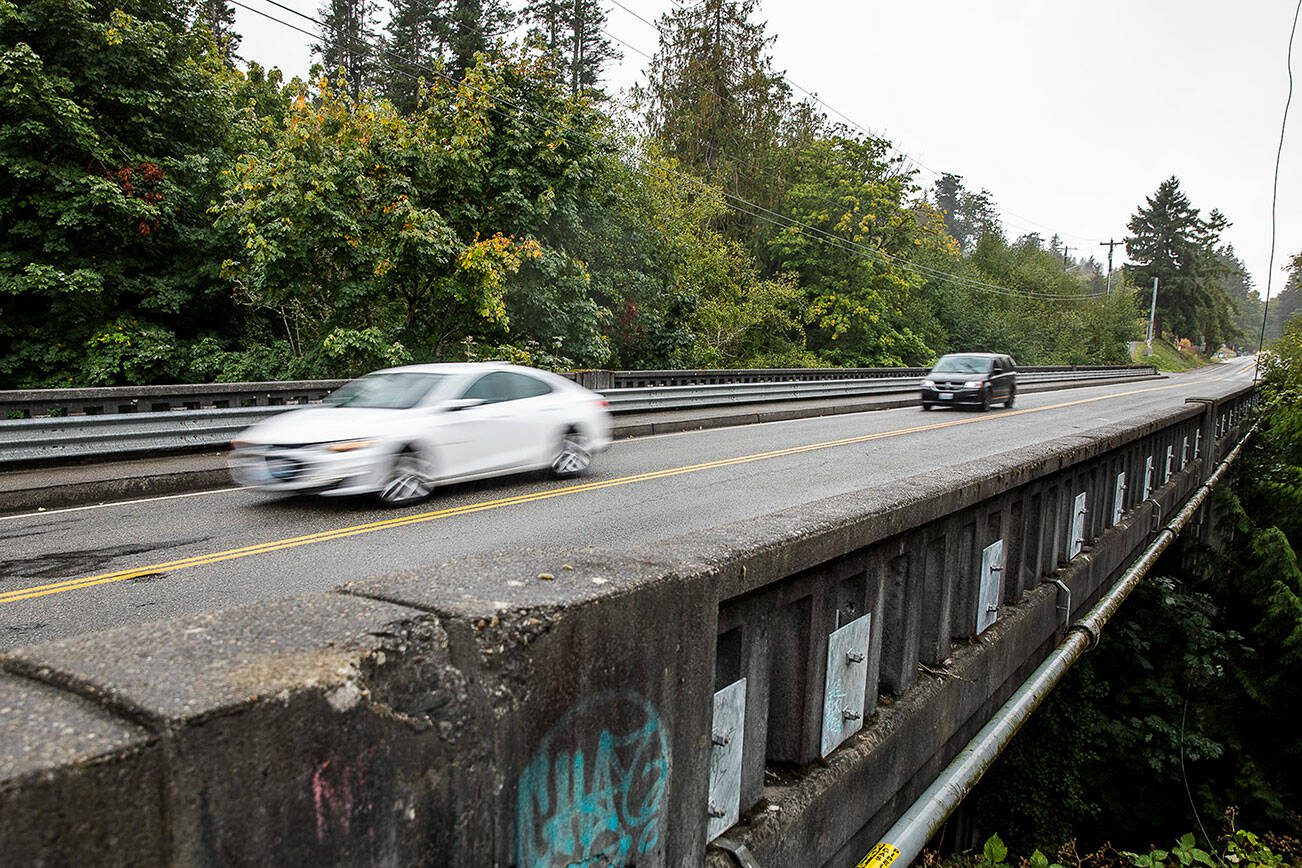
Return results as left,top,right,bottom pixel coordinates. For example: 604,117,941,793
0,384,1184,604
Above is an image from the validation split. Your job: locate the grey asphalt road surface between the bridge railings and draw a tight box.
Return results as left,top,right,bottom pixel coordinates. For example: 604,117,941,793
0,359,1253,648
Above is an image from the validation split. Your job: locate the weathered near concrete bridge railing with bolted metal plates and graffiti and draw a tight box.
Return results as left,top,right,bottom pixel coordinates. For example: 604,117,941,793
0,389,1255,867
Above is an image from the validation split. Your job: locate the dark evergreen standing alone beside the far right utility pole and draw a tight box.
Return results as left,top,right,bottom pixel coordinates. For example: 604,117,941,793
1126,177,1233,344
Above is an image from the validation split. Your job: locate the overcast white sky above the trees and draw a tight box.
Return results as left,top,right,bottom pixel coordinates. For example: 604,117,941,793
236,0,1302,294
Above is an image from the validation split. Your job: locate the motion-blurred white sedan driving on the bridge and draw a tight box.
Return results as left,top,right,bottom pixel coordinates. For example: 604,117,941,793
229,363,611,506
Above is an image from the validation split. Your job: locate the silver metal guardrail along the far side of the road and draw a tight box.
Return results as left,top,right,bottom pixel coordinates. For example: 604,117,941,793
0,367,1155,467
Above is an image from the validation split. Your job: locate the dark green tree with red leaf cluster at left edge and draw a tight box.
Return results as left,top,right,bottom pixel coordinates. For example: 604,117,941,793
0,0,258,385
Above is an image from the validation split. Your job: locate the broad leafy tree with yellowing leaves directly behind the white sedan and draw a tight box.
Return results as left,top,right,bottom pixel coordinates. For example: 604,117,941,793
217,48,614,371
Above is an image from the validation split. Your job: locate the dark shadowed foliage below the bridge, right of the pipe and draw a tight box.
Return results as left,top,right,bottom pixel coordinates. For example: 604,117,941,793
974,327,1302,865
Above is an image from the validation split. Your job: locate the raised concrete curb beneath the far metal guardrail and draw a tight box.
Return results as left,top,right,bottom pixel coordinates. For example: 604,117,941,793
0,375,1164,515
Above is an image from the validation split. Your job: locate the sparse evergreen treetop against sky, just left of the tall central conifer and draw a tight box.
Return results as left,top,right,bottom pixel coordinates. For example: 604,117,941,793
522,0,620,96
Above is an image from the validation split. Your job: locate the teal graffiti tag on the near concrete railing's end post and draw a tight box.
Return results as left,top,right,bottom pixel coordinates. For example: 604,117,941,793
516,692,669,868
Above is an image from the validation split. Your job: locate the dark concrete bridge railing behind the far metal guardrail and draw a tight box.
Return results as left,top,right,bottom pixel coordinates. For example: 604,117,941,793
0,364,1156,419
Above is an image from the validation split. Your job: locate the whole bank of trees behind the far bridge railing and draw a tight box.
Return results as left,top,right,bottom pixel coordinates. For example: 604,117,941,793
0,0,1182,387
